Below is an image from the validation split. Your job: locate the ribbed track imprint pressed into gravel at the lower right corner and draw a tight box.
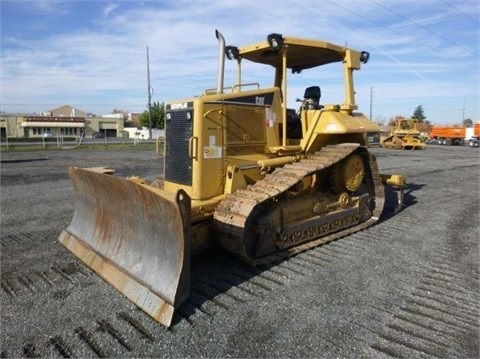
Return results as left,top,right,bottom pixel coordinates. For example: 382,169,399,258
371,200,480,358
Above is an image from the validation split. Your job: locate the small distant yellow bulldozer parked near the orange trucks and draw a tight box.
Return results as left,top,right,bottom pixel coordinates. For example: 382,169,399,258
382,118,426,150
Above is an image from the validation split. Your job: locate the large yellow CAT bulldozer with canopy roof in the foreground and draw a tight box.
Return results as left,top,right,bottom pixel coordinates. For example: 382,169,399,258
59,31,405,326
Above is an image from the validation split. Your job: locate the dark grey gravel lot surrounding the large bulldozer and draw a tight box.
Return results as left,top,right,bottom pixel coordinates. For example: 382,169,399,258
0,145,480,358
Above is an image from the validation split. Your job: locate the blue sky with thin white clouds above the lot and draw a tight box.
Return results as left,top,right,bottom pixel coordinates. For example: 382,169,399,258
0,0,480,124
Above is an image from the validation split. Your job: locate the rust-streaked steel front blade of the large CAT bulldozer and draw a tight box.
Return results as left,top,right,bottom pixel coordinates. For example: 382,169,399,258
59,167,190,326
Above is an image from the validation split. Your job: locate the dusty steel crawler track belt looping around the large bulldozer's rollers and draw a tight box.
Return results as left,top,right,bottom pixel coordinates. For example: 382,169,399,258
215,144,385,265
